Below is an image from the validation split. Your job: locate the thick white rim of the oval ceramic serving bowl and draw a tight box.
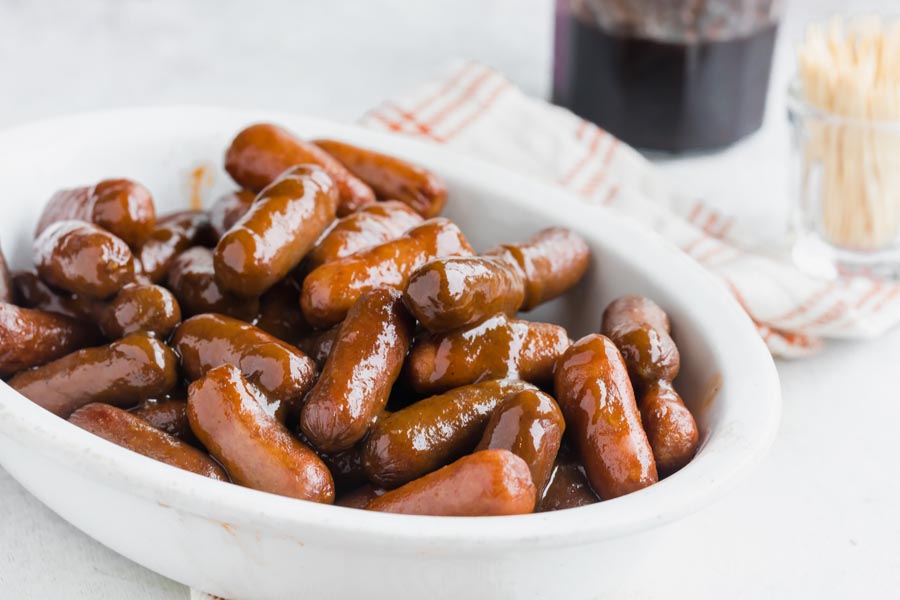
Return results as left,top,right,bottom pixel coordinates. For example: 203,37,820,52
0,106,781,553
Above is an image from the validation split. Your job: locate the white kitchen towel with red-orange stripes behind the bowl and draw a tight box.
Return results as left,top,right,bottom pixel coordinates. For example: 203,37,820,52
362,62,900,357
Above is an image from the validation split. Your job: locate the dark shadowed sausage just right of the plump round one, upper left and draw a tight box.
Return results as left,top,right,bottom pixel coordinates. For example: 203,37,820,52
138,210,213,283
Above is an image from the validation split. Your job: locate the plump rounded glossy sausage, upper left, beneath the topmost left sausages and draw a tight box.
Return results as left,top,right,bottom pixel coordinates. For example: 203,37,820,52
33,221,134,300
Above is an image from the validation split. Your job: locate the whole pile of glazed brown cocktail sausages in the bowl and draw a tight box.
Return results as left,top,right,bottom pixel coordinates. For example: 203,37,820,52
0,124,698,515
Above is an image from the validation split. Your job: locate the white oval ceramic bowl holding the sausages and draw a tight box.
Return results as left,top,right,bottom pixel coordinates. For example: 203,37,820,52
0,108,780,600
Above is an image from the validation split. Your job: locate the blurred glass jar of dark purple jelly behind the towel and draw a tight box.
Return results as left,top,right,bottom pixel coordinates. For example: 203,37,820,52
553,0,780,152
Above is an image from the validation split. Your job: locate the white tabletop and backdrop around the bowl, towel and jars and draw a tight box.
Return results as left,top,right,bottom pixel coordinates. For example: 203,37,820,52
0,0,900,600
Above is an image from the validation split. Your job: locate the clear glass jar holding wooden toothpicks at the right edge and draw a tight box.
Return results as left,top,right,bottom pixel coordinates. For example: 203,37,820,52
788,81,900,279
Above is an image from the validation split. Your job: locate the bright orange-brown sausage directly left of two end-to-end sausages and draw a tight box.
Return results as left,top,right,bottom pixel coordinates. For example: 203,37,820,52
300,218,472,329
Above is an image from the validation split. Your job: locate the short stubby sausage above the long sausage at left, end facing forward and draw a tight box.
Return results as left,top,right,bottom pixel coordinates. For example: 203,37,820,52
95,283,181,340
